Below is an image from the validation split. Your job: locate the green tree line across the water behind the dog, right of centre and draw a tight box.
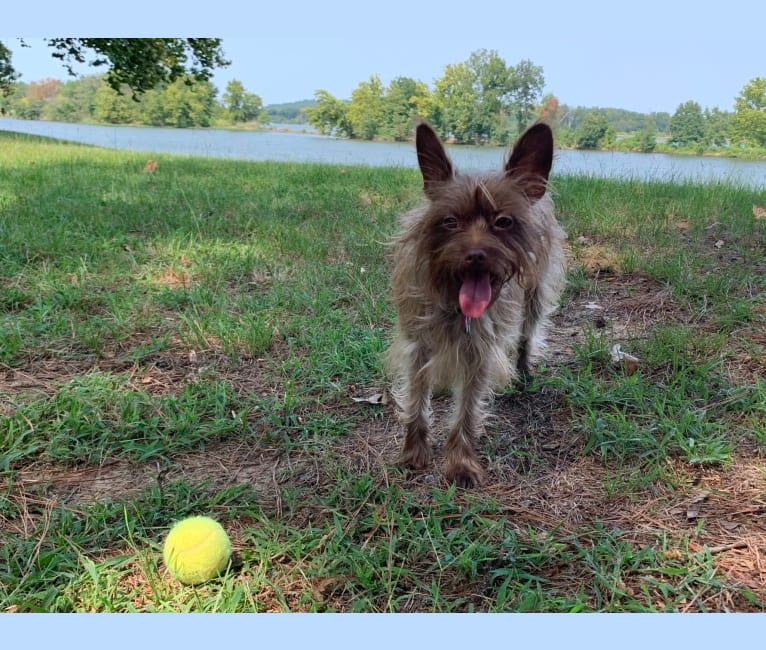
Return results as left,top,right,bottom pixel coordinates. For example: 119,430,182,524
304,50,766,155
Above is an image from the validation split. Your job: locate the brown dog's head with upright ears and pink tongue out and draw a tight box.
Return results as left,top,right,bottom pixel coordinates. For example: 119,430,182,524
416,124,553,318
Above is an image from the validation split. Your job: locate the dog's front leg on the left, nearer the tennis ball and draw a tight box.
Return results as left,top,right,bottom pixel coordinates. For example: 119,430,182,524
401,344,431,469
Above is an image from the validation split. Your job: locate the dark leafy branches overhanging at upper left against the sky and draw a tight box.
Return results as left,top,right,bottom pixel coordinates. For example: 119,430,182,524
0,38,230,97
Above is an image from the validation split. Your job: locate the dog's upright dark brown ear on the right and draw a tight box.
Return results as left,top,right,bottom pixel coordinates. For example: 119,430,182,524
505,122,553,200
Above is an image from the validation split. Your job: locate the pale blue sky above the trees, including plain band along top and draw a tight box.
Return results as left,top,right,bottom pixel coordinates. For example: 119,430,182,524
0,0,766,114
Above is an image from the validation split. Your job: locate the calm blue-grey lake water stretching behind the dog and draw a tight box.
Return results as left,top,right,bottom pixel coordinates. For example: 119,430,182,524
0,118,766,189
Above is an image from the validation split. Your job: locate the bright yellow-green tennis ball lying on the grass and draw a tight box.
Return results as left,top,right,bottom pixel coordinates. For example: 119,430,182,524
162,517,231,585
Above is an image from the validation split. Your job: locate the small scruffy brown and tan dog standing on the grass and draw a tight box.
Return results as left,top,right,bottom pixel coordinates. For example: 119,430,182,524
384,122,566,488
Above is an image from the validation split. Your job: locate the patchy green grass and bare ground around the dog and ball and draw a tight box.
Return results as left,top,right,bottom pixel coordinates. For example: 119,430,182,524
0,133,766,612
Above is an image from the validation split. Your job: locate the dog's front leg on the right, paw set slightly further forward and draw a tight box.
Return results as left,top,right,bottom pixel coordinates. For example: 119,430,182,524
444,369,489,488
